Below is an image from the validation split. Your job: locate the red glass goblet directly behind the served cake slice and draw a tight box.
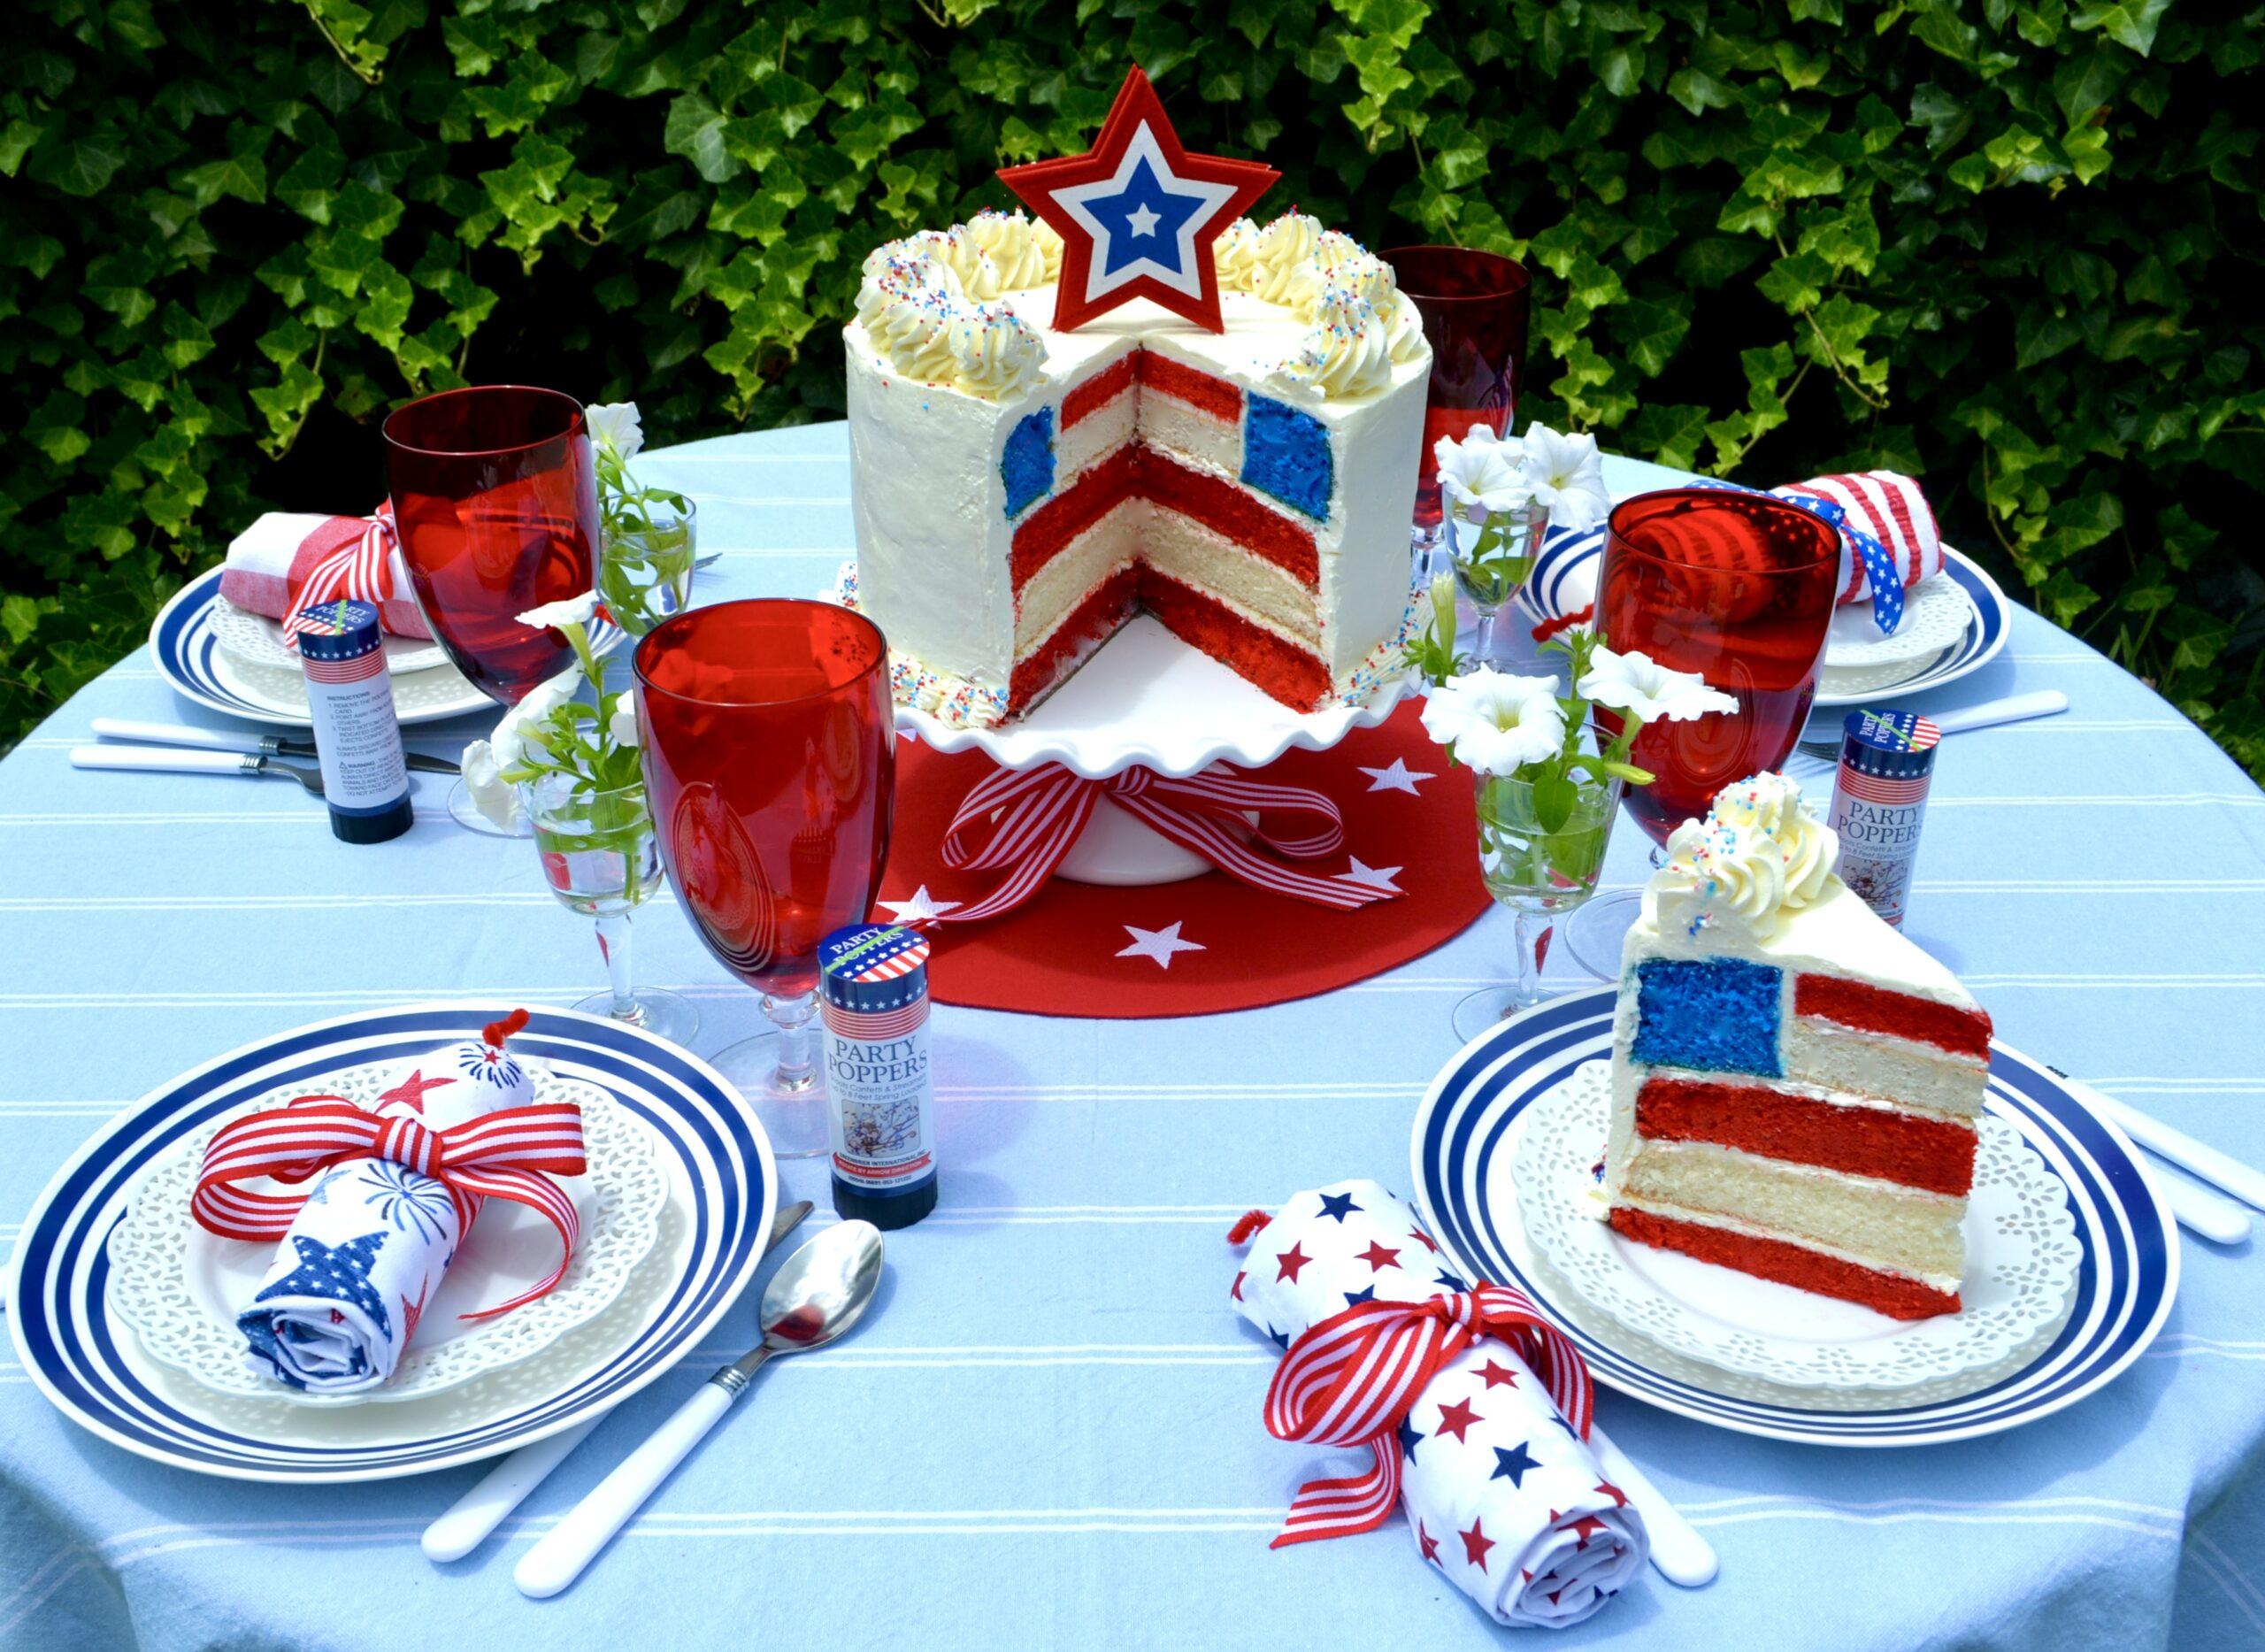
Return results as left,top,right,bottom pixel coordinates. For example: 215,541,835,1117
1565,488,1841,979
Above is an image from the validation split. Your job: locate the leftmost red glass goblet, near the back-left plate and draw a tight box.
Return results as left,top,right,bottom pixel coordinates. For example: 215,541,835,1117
385,385,598,836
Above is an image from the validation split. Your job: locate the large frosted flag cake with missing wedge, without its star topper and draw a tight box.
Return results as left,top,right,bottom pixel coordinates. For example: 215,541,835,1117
845,213,1432,726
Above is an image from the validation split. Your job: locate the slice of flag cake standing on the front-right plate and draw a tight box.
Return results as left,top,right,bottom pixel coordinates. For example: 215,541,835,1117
1606,775,1991,1319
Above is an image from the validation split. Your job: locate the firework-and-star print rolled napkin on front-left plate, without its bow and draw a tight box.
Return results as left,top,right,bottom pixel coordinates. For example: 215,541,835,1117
235,1024,534,1394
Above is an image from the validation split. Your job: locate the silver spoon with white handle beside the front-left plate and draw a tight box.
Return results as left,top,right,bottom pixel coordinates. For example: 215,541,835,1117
512,1221,881,1600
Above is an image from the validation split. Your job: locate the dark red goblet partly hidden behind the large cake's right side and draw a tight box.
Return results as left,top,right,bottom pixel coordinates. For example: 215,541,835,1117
1382,247,1532,560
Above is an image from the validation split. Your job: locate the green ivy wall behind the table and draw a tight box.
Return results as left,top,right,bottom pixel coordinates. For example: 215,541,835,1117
0,0,2265,772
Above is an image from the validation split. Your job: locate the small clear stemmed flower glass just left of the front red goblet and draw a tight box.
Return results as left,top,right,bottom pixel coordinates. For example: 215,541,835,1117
523,772,700,1045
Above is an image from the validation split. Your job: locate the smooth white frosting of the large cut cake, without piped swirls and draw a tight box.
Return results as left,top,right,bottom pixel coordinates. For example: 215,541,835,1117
842,288,1429,695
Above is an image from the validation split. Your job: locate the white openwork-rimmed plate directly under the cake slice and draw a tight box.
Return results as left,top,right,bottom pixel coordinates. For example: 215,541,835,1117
1513,1061,2077,1389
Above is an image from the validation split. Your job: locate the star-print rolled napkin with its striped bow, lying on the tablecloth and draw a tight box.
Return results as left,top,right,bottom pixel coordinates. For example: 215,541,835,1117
1228,1180,1649,1629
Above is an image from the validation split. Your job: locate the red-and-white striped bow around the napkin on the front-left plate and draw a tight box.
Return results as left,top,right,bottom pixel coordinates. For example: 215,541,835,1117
188,1095,589,1319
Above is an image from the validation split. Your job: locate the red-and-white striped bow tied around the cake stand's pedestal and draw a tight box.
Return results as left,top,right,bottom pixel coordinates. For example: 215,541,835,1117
926,764,1391,925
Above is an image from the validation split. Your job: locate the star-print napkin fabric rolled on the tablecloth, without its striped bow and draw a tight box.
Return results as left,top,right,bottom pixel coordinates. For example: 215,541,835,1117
1230,1180,1649,1629
